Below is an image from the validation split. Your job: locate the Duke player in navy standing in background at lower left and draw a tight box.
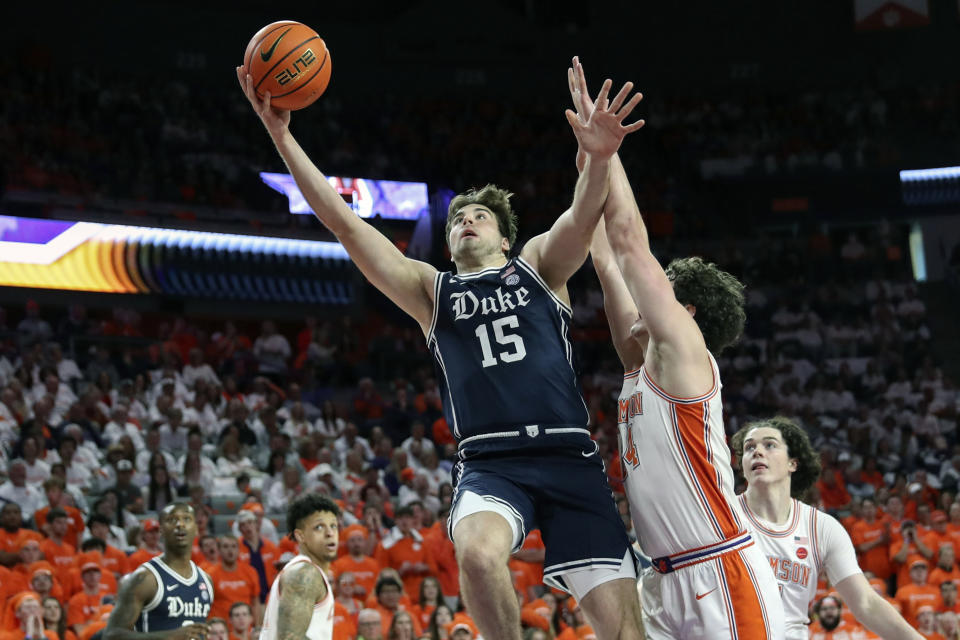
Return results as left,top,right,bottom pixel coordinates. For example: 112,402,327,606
103,502,213,640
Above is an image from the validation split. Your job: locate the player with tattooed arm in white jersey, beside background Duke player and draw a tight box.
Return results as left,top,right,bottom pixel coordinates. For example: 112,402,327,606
260,493,340,640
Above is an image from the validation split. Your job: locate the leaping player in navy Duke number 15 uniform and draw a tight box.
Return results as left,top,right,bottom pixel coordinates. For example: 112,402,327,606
237,60,643,640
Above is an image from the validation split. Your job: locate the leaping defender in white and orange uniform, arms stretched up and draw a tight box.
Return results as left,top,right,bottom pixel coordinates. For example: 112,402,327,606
568,60,784,640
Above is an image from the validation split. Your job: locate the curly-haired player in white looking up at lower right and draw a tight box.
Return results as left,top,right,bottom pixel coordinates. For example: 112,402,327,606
731,416,922,640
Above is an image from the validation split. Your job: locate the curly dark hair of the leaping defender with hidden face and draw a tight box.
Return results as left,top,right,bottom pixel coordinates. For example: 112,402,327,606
666,257,747,356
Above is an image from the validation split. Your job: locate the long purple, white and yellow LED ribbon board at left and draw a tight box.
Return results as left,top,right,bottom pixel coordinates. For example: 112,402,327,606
0,216,353,304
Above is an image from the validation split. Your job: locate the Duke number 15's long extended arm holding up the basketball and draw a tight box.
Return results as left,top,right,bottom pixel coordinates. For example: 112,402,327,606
237,67,436,327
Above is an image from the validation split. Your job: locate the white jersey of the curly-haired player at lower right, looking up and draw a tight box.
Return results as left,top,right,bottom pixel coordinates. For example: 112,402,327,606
738,494,862,640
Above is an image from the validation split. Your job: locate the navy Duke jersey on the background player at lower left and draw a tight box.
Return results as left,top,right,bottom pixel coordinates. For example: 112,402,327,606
133,556,213,633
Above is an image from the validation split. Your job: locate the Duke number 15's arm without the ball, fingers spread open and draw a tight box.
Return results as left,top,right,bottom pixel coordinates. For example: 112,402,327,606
523,57,643,290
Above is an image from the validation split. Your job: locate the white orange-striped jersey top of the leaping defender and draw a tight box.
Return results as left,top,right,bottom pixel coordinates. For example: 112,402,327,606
617,356,747,557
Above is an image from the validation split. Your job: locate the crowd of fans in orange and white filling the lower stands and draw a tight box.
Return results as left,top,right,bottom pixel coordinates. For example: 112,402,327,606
0,222,960,640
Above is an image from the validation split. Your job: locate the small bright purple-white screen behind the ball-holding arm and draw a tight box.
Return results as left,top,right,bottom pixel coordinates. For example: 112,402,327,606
260,171,430,220
